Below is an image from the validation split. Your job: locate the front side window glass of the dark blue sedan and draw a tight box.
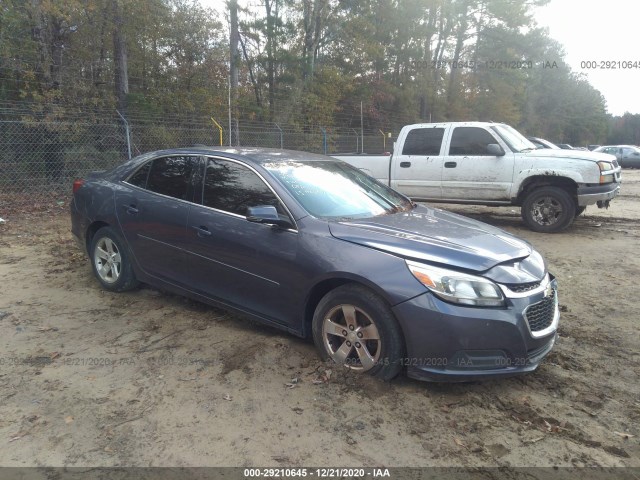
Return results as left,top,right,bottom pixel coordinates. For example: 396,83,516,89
202,158,288,218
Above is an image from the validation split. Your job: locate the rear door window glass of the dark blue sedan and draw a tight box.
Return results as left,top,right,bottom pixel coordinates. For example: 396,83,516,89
147,156,198,200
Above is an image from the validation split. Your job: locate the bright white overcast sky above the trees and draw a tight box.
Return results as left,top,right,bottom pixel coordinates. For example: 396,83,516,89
200,0,640,115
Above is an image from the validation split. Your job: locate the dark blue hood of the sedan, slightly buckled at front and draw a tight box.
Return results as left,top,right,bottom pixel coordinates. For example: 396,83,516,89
329,205,533,272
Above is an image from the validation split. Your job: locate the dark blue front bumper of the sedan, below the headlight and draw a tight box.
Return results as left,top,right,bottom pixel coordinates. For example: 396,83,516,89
393,280,560,382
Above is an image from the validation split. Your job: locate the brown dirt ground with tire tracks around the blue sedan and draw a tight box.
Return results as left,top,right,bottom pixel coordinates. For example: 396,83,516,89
0,170,640,467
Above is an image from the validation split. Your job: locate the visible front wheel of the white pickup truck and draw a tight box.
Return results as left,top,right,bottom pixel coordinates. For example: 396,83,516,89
522,187,576,233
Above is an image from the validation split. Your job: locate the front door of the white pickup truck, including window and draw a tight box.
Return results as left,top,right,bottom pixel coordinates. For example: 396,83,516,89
442,127,514,202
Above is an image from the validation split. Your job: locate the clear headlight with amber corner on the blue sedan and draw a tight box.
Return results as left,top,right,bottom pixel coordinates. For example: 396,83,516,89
406,260,505,307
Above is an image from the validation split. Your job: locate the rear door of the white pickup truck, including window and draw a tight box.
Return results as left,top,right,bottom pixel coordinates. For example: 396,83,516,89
391,127,445,200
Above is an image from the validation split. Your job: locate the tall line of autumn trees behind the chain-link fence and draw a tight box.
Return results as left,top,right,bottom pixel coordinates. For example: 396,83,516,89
0,0,638,145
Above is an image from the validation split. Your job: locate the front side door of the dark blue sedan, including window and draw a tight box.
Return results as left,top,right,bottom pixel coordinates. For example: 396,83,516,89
180,157,302,328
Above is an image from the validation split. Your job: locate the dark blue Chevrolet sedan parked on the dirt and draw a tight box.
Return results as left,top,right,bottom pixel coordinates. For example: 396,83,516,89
71,147,559,381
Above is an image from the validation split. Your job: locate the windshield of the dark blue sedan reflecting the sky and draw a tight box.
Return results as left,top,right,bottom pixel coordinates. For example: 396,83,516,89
264,161,413,220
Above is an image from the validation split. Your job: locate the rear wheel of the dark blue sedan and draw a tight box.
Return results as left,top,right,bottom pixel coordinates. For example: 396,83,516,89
90,227,138,292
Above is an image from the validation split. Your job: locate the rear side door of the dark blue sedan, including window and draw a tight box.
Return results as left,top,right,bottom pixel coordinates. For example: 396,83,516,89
115,155,200,286
